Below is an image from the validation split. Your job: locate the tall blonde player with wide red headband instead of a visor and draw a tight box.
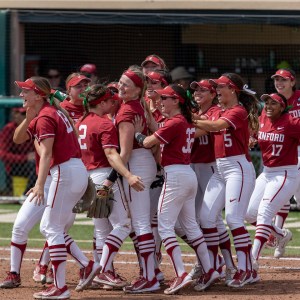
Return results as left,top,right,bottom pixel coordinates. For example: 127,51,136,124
115,67,160,293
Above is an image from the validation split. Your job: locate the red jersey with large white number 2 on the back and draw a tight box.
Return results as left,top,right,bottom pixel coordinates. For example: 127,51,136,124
75,112,119,170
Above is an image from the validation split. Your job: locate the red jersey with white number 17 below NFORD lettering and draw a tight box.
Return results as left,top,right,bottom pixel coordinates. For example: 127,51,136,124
258,110,300,168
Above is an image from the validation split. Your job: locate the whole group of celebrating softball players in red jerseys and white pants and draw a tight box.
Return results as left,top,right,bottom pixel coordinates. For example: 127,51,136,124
0,55,300,299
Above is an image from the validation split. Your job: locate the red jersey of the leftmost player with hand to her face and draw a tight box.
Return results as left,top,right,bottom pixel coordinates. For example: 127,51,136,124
27,103,81,168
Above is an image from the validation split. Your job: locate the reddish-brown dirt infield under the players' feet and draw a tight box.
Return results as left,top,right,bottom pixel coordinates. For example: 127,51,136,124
0,249,300,300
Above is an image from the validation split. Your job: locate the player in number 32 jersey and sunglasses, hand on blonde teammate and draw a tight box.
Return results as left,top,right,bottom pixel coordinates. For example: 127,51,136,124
135,84,219,294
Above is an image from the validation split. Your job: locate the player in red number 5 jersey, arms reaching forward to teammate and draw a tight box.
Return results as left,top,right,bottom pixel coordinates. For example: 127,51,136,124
196,73,258,287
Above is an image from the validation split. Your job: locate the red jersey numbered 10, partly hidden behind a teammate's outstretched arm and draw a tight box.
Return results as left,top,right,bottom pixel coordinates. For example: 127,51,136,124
191,105,220,163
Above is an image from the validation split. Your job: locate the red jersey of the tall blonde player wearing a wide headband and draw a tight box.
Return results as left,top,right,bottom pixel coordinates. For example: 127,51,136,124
115,99,148,149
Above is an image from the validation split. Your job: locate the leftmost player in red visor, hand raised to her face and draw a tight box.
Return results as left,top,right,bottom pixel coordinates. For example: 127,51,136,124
10,77,100,299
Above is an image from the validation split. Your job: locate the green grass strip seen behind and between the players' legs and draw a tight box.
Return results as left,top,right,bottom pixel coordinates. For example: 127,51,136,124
0,204,300,256
